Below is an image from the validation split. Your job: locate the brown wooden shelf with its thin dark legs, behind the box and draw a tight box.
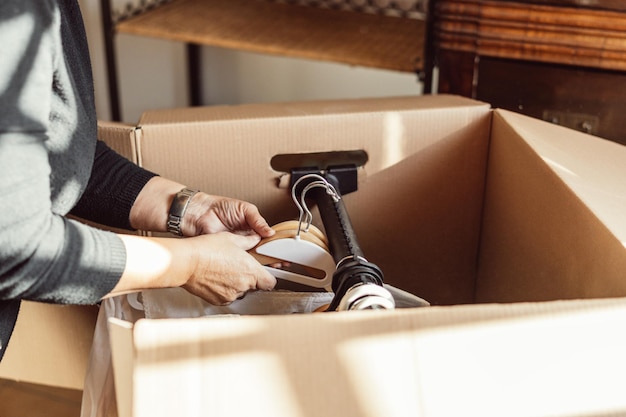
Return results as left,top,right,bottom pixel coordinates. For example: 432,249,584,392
101,0,432,120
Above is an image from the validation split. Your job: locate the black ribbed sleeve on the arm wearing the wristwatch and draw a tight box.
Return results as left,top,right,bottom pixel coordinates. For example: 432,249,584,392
70,141,156,230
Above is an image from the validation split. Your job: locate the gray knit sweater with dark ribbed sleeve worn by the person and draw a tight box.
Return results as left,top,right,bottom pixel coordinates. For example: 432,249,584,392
0,0,154,359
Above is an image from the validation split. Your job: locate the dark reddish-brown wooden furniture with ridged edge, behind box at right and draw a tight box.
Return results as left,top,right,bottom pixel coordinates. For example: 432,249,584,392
433,0,626,144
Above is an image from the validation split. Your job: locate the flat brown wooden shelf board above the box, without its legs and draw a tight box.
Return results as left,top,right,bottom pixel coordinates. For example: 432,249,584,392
116,0,426,72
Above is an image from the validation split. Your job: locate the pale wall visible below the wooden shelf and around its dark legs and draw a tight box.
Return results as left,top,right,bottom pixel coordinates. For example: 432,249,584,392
80,0,422,123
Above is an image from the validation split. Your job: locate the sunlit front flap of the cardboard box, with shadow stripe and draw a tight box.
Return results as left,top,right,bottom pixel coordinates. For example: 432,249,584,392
112,300,626,417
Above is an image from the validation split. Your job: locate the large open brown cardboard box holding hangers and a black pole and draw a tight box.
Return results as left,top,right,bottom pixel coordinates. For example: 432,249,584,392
1,96,626,417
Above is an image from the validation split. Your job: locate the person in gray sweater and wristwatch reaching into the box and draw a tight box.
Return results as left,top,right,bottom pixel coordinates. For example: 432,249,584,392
0,0,276,359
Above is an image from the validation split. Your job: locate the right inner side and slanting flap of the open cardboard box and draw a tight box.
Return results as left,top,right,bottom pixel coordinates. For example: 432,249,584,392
476,110,626,302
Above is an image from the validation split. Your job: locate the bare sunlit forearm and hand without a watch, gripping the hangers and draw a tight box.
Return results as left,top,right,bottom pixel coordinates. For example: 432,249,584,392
109,232,276,305
